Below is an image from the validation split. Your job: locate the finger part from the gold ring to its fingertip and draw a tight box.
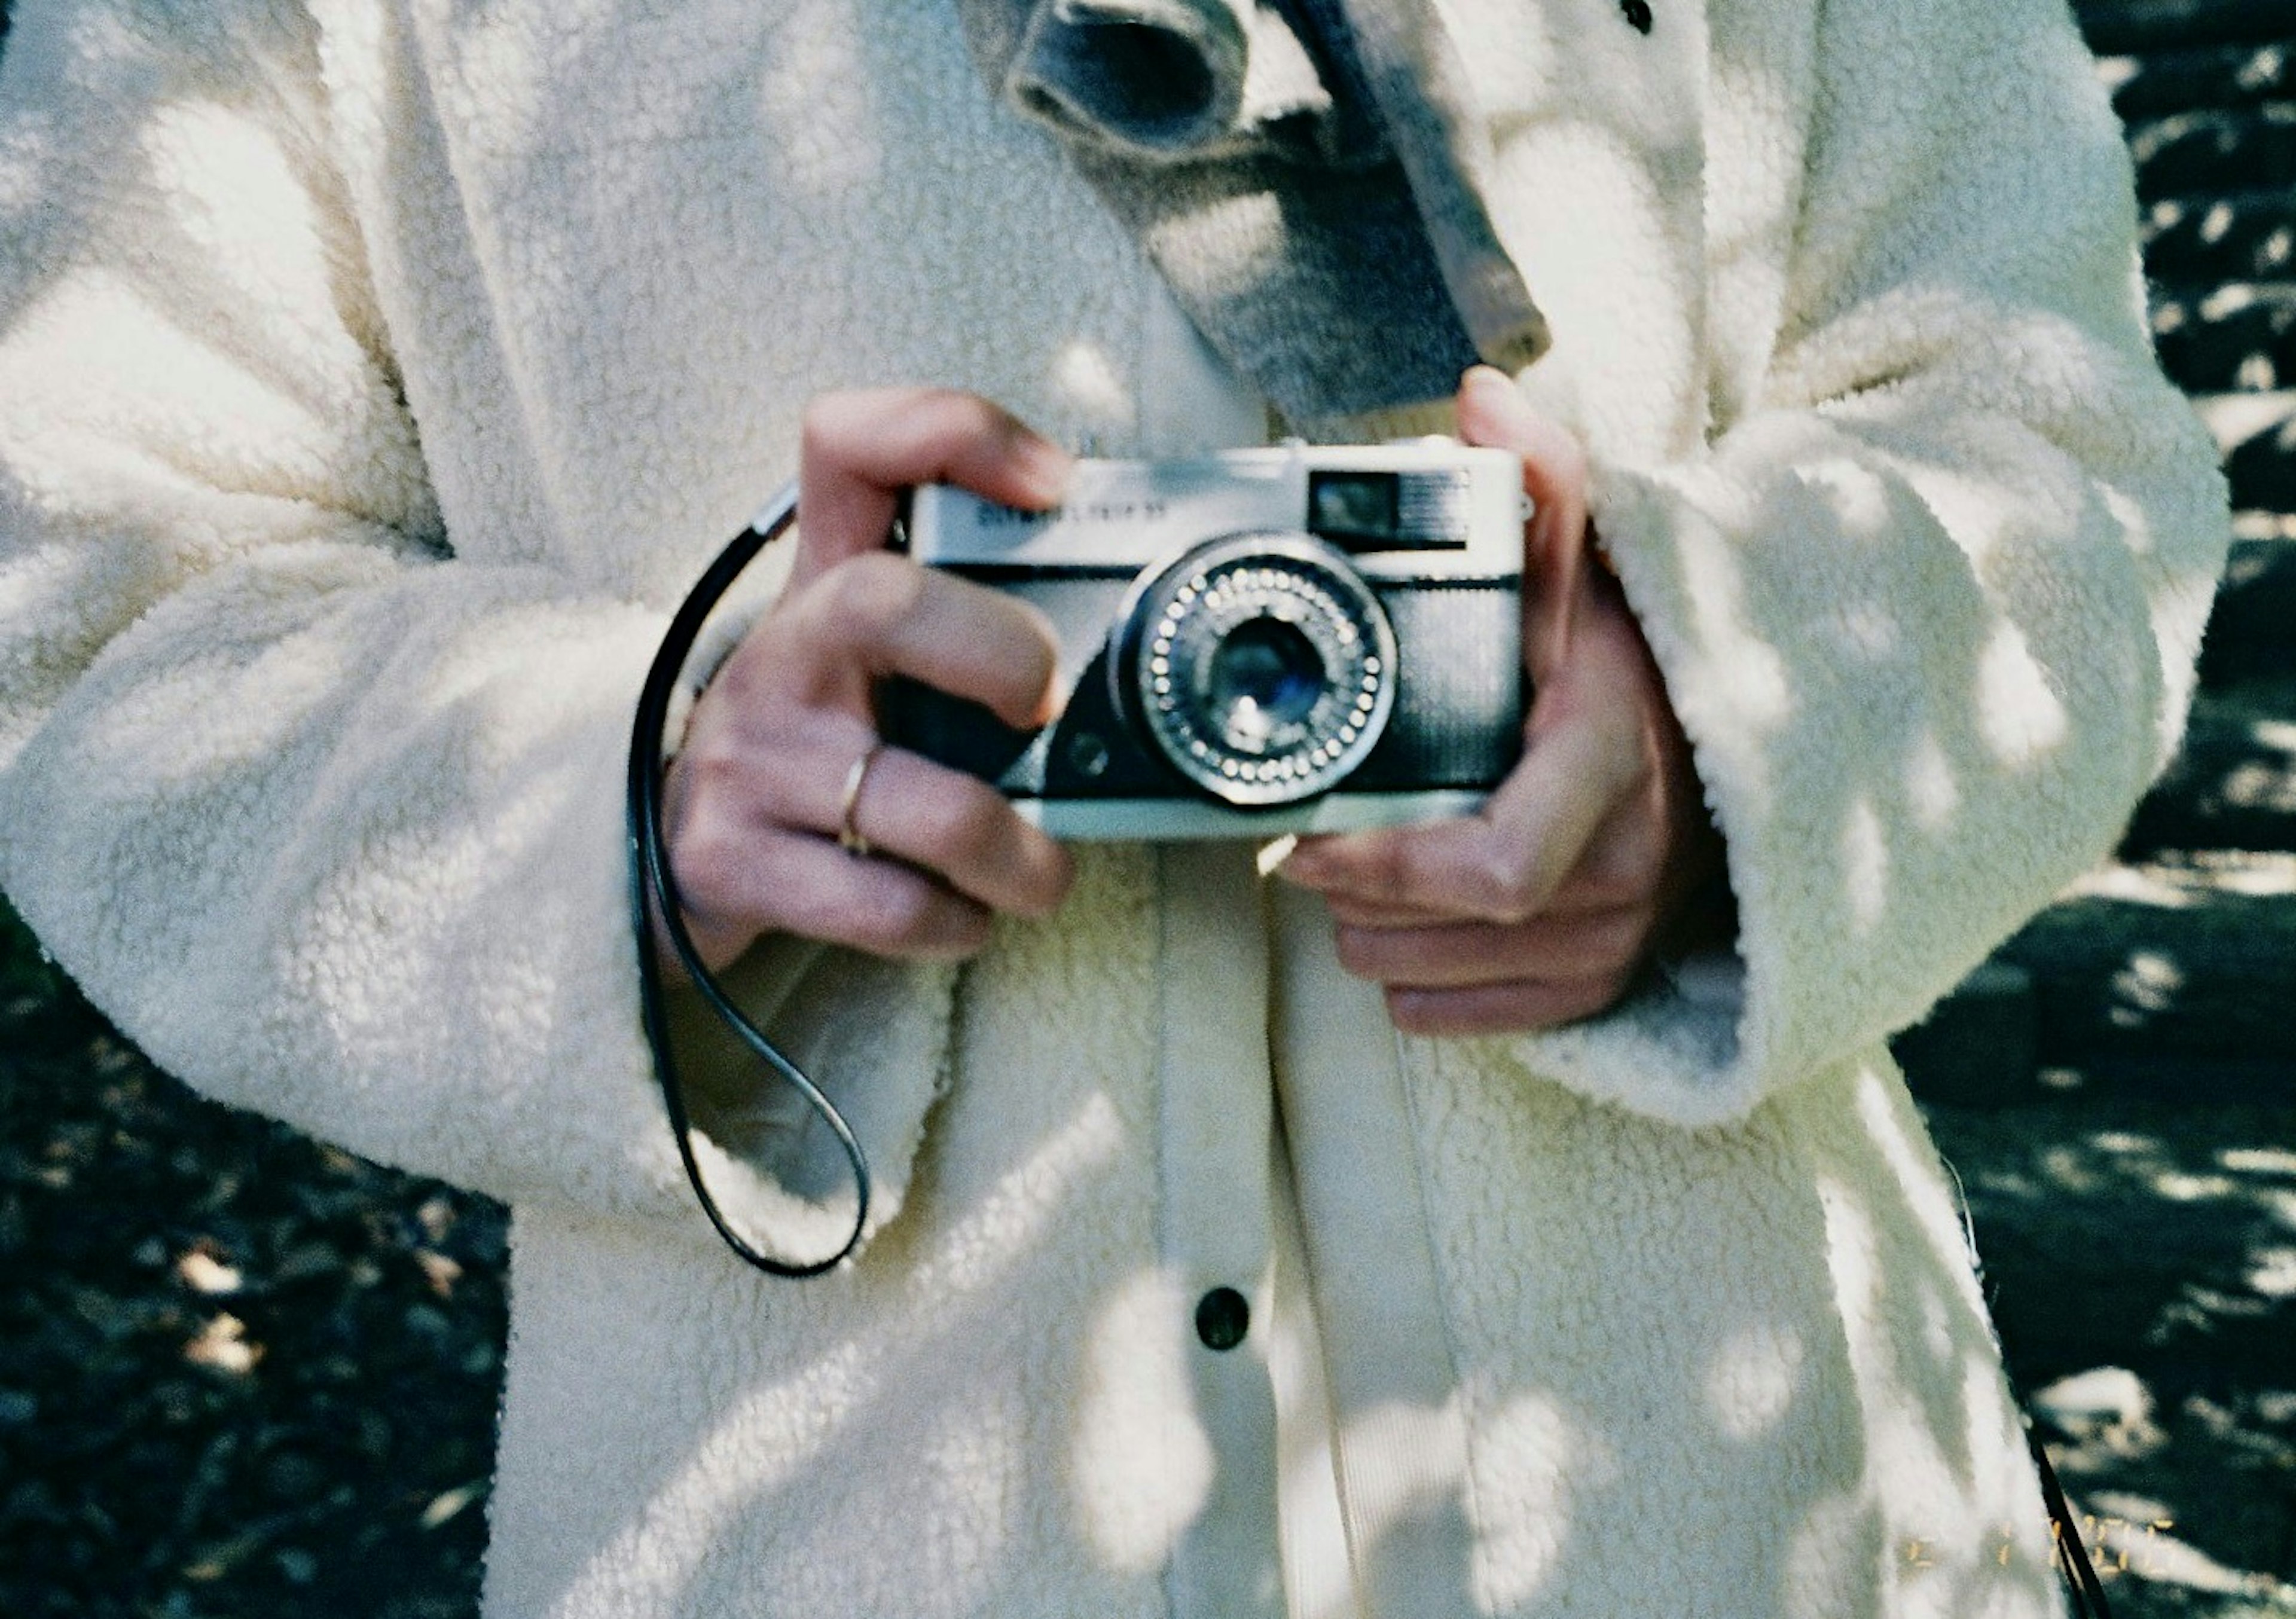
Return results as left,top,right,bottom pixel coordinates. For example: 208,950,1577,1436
840,749,1074,917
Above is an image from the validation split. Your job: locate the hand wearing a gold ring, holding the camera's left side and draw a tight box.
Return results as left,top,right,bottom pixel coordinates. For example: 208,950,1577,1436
664,388,1072,972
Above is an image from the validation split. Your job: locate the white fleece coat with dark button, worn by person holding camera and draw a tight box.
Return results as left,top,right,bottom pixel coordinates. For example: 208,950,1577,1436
0,0,2225,1619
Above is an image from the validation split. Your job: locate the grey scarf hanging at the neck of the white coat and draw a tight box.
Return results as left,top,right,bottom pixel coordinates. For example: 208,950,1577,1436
957,0,1547,425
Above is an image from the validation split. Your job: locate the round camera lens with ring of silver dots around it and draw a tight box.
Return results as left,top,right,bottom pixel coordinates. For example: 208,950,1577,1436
1112,535,1396,806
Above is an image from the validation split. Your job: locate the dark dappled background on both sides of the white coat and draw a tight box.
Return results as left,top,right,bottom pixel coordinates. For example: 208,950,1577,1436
0,0,2296,1619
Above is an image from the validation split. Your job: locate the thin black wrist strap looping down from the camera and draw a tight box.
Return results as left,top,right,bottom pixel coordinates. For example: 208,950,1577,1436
629,480,868,1277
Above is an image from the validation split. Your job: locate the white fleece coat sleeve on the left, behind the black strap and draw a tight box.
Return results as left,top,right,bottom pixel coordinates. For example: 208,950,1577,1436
0,0,946,1240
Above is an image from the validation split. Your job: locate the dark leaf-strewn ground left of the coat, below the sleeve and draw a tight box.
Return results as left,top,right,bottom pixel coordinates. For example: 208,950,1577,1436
0,909,503,1619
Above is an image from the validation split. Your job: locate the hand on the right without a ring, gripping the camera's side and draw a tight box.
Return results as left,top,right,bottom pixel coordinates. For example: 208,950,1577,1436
1279,368,1727,1034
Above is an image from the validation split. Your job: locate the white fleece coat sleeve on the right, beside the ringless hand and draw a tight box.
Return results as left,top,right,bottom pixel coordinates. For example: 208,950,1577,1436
1497,0,2227,1125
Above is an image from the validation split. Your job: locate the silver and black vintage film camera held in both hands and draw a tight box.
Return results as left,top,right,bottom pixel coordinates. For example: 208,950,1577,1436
880,439,1527,841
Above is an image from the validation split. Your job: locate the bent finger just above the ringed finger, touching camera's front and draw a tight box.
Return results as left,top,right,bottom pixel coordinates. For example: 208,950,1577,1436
758,554,1058,730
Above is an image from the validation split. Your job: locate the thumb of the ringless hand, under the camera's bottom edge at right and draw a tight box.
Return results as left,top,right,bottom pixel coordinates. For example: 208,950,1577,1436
1277,726,1632,923
